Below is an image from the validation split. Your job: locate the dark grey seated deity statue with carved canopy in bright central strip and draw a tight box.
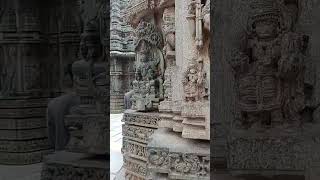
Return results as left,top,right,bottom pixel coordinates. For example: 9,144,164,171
131,21,164,111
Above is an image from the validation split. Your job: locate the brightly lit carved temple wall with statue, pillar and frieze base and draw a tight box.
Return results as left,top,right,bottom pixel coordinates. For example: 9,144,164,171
122,0,210,179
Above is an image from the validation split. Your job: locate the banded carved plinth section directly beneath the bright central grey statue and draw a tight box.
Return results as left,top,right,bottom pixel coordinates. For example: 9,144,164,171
122,110,160,180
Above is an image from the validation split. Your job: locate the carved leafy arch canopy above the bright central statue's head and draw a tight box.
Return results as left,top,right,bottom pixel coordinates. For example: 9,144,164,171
135,21,162,48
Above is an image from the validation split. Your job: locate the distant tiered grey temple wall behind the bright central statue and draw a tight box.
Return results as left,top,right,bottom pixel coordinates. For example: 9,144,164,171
110,0,135,113
